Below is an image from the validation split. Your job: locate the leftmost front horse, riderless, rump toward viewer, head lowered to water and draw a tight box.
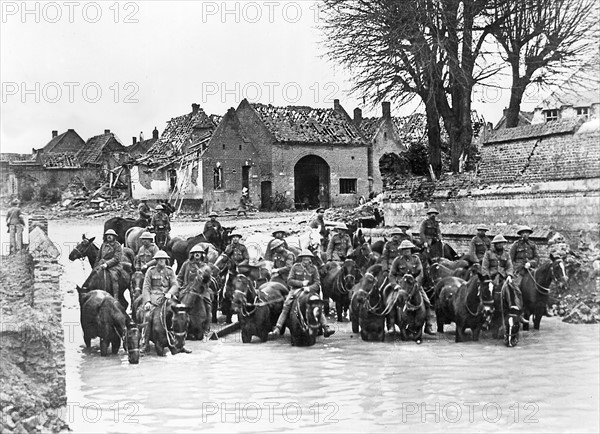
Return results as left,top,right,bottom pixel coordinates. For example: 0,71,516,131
77,287,139,364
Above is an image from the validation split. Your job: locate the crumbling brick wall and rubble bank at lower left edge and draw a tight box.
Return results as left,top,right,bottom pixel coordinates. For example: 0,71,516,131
0,248,68,433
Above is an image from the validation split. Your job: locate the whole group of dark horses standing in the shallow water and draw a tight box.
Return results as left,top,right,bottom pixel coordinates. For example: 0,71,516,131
69,219,566,363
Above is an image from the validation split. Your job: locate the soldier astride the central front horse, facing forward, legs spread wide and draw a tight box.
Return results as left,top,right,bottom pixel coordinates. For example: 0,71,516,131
272,249,335,338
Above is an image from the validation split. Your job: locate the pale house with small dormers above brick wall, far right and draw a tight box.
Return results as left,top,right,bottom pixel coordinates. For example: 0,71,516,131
532,54,600,124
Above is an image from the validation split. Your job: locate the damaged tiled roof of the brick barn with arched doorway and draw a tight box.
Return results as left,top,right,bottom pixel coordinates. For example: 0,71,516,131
250,103,366,145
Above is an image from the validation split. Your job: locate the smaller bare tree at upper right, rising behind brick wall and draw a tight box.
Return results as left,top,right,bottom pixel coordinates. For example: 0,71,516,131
489,0,598,128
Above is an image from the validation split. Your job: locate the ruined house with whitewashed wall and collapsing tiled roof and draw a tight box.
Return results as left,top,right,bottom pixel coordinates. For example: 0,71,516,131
130,104,218,201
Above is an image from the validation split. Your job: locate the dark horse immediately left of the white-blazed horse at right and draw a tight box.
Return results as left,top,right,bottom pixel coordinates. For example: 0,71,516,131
453,274,494,342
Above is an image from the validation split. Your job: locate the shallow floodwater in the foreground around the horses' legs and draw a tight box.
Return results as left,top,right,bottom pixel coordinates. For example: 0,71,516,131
49,221,600,433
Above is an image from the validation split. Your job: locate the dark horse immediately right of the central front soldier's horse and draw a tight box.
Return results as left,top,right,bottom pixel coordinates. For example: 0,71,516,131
321,259,362,322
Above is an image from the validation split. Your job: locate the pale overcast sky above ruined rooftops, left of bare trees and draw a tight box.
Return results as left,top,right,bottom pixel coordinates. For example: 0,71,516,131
0,1,535,153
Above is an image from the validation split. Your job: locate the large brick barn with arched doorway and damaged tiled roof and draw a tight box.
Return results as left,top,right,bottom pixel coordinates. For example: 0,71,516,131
202,99,369,214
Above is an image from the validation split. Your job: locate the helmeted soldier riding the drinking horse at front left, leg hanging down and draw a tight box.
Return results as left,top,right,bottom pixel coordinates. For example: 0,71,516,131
141,250,189,352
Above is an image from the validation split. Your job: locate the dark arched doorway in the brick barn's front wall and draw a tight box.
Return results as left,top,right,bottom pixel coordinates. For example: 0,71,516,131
294,155,329,208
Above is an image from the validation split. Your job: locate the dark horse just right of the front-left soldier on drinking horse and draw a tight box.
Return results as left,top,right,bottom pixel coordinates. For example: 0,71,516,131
179,264,213,340
